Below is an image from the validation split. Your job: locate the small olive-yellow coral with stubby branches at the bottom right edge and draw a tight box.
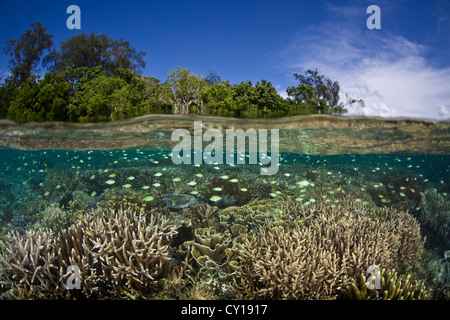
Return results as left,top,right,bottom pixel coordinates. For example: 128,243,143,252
337,268,430,300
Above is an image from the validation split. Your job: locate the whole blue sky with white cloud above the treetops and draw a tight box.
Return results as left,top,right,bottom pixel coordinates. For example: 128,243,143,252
0,0,450,120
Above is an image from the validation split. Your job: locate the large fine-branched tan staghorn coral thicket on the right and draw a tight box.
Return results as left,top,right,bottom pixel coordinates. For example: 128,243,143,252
233,198,423,299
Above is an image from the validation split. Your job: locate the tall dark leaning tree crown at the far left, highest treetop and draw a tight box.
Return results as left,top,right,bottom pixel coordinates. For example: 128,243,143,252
4,22,53,86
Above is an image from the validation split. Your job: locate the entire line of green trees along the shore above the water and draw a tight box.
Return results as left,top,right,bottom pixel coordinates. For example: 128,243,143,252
0,22,345,123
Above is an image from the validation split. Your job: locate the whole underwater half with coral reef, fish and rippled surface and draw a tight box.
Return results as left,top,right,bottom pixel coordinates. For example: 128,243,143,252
0,115,450,300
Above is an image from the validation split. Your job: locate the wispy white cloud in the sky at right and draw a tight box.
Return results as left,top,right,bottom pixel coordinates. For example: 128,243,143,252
282,14,450,120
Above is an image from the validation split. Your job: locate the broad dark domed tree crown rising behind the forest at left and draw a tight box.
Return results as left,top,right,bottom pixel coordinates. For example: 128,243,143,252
44,32,146,75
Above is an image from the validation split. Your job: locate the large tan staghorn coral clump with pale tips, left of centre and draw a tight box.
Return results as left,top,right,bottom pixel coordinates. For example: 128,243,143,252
71,205,176,296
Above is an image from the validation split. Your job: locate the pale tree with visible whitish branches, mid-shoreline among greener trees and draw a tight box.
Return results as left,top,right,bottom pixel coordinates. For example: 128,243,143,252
165,67,207,114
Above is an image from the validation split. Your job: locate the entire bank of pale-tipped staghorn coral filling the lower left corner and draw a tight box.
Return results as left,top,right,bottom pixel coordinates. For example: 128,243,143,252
0,208,183,298
